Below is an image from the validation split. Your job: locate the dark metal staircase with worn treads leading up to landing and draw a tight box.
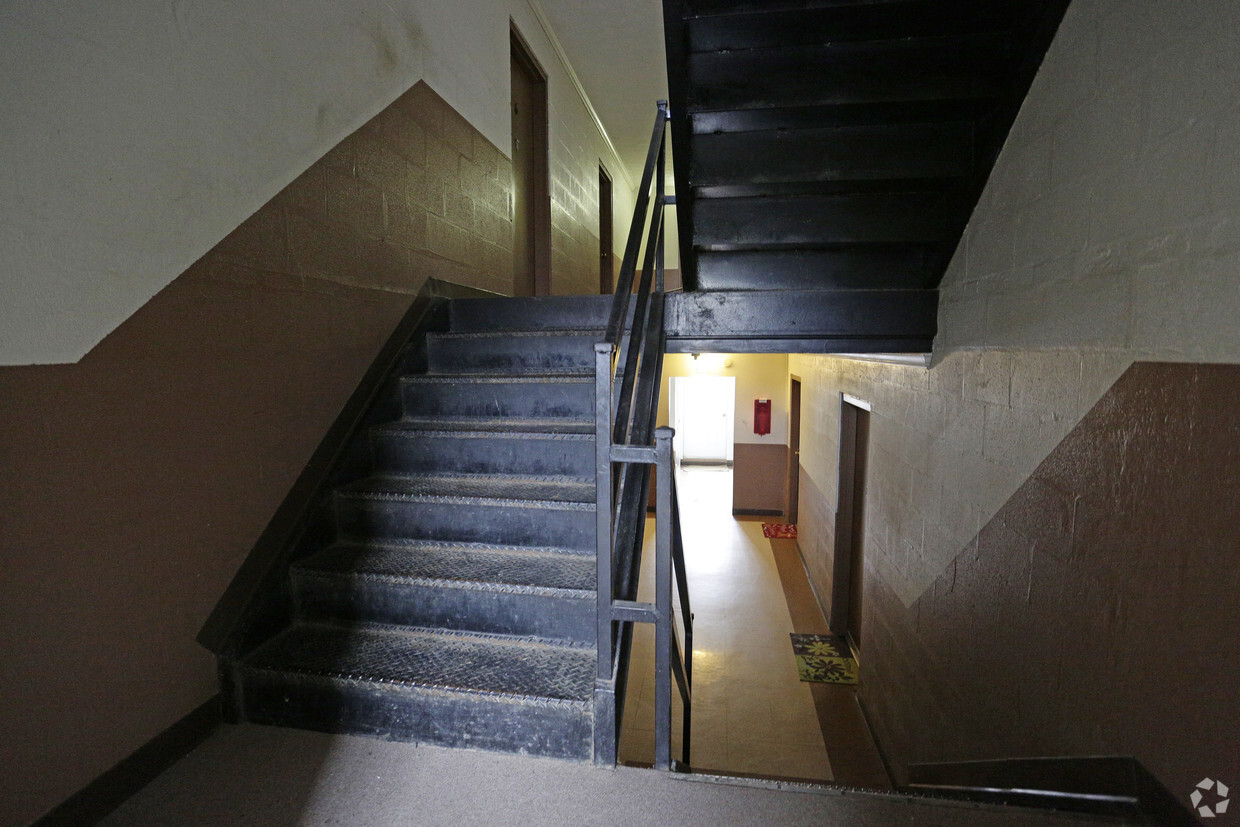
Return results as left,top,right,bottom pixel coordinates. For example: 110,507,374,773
221,296,610,760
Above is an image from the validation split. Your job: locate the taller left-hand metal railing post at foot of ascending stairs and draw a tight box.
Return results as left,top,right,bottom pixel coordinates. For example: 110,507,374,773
594,342,615,678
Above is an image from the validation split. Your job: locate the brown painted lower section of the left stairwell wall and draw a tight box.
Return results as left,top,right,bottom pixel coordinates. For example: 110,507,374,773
0,83,523,825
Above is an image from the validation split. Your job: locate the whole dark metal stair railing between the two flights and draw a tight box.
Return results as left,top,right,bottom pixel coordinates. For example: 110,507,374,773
594,100,693,769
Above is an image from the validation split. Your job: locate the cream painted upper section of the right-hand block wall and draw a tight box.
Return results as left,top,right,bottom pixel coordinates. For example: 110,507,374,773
790,0,1240,605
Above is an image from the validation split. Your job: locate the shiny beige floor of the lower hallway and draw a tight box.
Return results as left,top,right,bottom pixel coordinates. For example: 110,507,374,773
620,469,832,781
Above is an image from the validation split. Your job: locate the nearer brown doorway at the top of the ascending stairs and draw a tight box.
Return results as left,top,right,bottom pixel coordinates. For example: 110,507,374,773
510,27,551,296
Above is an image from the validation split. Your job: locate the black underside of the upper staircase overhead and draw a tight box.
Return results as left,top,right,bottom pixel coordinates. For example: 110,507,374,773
663,0,1066,352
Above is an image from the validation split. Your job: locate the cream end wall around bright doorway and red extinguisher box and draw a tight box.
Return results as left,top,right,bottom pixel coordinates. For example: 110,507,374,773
658,353,789,445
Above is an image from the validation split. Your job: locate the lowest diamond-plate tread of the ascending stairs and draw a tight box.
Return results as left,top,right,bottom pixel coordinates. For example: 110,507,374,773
244,624,596,704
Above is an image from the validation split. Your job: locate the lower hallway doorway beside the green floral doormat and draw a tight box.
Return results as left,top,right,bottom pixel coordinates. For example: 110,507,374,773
831,394,869,658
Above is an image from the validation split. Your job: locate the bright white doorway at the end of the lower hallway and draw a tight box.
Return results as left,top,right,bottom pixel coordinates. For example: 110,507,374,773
668,376,737,466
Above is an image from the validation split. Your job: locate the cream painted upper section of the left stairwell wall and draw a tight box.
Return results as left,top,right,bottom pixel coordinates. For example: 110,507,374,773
0,0,631,365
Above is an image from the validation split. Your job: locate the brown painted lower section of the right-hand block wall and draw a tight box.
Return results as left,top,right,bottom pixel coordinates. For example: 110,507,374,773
862,363,1240,797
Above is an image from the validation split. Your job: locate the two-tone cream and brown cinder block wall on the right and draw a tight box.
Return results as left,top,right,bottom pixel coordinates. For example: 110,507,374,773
790,0,1240,800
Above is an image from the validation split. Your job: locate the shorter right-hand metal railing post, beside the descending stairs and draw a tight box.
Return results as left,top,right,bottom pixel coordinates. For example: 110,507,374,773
655,425,676,770
